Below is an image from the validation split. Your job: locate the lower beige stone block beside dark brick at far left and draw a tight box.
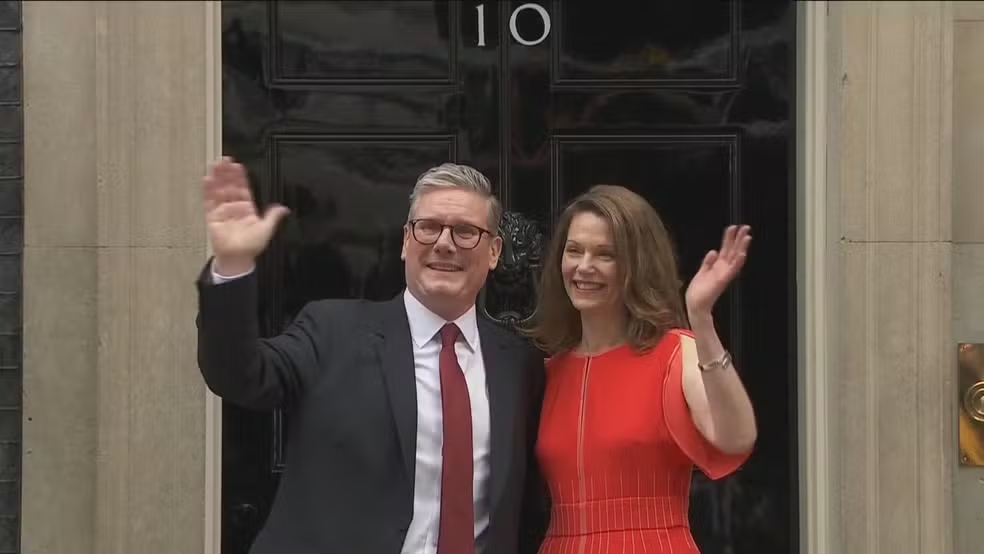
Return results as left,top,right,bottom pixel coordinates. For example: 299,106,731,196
21,246,99,554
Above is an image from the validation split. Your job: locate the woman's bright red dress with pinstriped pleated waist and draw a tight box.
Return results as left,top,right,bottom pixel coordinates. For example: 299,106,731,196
536,331,748,554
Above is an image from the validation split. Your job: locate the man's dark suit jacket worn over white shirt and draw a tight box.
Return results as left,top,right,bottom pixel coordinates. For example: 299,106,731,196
197,263,549,554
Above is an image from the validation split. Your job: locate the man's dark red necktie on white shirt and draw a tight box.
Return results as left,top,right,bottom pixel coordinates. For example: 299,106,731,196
437,323,475,554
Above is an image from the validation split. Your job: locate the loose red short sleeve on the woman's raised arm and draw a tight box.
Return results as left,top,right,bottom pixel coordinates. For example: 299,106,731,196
663,330,751,480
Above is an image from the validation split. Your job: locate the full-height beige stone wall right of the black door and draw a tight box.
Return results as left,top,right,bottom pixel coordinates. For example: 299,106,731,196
827,1,956,554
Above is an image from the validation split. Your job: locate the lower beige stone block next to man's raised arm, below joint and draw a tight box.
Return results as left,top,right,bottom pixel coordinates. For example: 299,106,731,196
130,247,205,552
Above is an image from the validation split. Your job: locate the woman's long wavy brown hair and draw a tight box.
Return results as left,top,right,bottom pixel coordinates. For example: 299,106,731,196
527,185,687,355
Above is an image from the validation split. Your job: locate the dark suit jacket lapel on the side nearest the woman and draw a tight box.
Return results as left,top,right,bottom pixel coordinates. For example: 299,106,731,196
478,318,518,507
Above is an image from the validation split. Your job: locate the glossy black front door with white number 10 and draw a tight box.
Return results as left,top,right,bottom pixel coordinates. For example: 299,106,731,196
222,0,798,554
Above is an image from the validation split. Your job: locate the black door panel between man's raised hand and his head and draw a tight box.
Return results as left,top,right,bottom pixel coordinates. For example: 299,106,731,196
270,134,457,306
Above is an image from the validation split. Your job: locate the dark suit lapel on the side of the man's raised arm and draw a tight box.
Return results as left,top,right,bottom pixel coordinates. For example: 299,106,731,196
370,295,417,491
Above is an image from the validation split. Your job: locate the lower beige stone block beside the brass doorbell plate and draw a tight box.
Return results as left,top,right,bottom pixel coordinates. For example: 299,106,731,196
834,243,954,554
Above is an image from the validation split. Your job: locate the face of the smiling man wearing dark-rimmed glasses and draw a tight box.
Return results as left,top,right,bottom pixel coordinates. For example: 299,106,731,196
400,188,502,320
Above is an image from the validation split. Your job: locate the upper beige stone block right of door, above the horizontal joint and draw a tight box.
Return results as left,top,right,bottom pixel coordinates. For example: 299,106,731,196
831,2,950,241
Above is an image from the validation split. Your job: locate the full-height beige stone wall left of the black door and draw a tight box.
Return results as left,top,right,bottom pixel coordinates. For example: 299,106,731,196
22,1,214,554
